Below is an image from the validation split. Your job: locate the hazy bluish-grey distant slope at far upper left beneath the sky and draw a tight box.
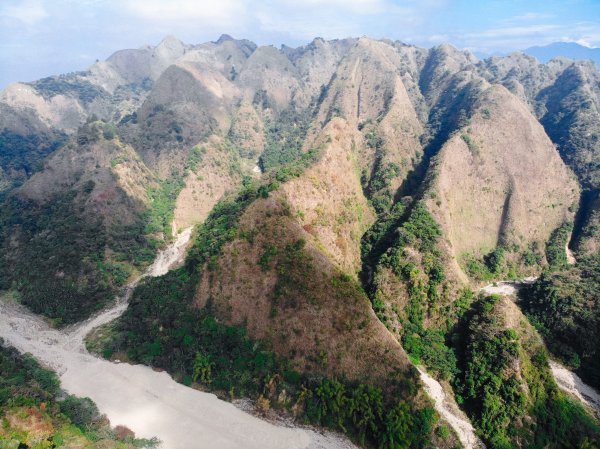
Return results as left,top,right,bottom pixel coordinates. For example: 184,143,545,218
0,38,188,196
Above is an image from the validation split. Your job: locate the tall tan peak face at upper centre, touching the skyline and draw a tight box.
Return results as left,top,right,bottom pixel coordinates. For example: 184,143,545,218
311,38,423,198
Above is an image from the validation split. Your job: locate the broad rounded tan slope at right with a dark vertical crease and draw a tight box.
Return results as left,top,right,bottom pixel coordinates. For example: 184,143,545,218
428,82,579,274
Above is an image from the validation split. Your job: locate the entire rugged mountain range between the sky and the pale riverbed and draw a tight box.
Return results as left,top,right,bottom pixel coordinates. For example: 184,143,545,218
0,35,600,448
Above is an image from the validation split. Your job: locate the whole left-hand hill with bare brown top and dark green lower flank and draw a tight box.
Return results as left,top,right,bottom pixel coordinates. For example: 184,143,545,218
0,123,155,322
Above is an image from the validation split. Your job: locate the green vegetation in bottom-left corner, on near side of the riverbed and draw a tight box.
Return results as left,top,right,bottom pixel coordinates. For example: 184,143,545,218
0,344,159,449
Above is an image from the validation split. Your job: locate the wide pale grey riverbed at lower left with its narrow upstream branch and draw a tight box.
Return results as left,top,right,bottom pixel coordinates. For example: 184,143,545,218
0,230,356,449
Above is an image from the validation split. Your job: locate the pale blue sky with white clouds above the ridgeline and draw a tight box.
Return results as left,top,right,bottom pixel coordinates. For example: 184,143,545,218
0,0,600,89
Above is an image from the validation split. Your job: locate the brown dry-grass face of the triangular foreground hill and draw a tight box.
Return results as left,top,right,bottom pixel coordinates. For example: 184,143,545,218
196,194,408,382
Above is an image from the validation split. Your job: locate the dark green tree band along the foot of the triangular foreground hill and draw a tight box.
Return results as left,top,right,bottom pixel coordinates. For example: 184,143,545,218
98,262,435,449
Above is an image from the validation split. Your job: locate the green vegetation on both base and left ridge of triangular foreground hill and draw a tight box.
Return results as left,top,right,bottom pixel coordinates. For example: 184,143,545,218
95,150,436,449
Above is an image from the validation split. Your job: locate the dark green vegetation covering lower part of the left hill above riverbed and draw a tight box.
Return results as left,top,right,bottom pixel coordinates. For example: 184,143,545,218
0,187,153,324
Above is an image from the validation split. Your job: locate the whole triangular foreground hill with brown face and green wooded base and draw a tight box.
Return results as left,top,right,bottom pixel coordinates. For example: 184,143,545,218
95,152,452,448
